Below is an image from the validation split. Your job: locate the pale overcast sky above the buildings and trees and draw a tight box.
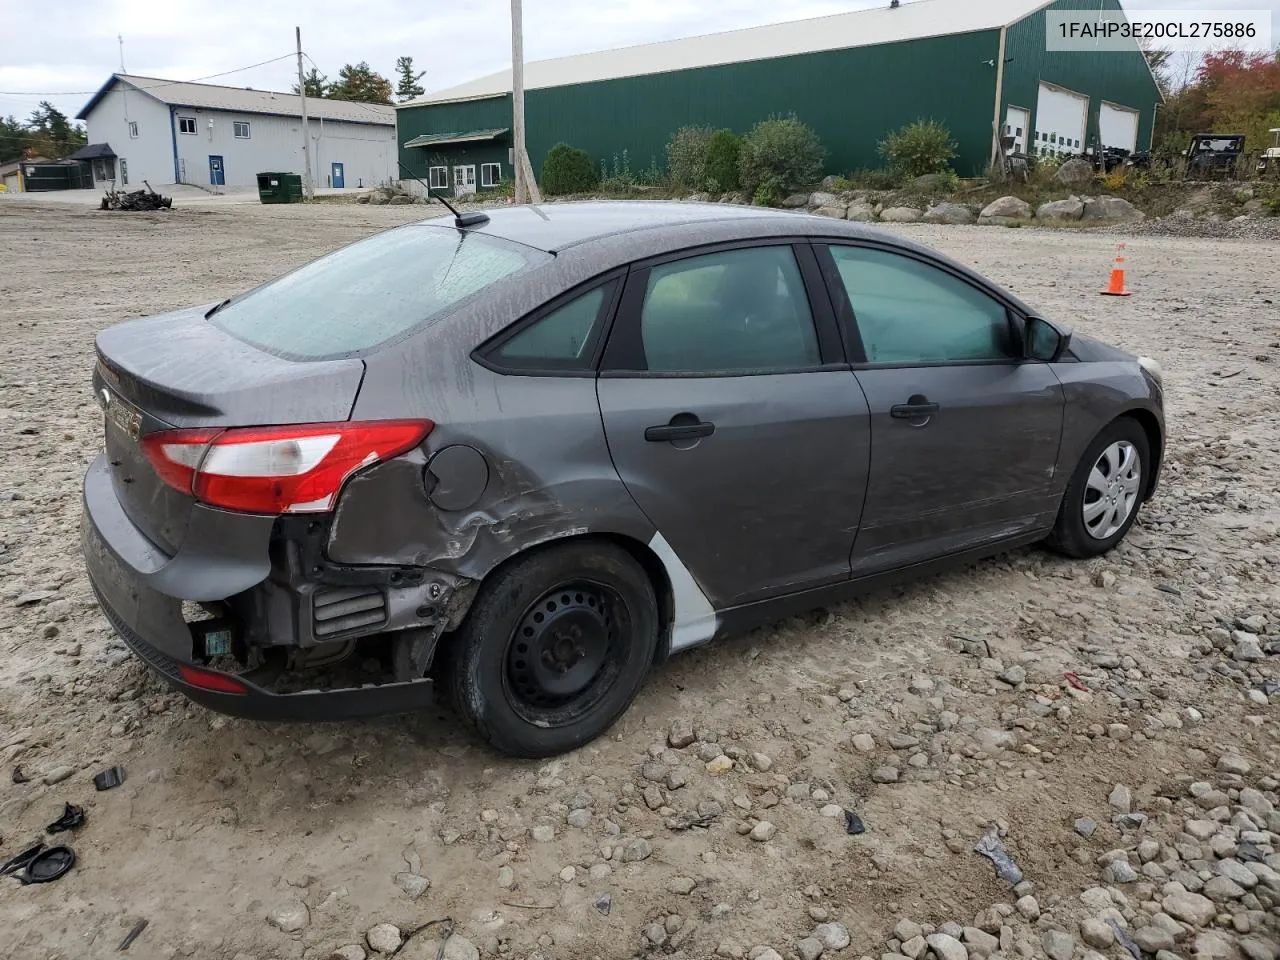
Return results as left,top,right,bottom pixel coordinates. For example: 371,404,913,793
0,0,1280,124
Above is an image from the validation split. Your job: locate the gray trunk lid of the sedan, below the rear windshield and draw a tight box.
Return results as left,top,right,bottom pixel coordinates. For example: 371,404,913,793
93,305,365,554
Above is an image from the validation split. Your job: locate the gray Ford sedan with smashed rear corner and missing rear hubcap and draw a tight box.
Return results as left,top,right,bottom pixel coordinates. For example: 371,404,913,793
82,204,1165,756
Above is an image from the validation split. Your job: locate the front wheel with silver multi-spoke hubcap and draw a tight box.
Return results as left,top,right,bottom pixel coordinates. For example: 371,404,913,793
1048,417,1151,558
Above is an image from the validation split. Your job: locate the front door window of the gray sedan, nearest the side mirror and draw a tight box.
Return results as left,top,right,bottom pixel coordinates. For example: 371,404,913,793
831,247,1011,364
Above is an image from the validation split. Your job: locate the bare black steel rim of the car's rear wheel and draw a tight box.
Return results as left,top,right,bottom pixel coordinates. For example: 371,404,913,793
503,580,630,726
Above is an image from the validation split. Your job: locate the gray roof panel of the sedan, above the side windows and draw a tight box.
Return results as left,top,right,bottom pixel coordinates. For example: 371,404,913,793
414,200,810,253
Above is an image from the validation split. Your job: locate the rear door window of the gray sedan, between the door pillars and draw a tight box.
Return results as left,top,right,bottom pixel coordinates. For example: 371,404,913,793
640,246,820,374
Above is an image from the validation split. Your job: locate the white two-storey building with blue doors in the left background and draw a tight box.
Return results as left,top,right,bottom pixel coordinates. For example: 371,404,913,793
77,73,396,189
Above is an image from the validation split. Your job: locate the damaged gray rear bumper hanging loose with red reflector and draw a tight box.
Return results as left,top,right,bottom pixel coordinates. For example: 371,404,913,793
81,457,434,721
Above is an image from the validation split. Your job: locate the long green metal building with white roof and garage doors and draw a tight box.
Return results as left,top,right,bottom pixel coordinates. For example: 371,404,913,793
397,0,1162,195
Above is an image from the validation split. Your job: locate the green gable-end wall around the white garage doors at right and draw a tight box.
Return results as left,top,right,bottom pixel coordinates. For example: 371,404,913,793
1001,0,1160,156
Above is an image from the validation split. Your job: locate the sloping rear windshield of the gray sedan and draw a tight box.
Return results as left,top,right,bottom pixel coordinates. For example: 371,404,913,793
210,225,552,360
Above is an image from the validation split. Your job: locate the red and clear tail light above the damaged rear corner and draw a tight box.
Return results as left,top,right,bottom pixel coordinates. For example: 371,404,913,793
142,420,435,513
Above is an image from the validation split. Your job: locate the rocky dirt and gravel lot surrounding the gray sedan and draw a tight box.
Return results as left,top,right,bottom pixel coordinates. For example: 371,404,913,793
0,202,1280,960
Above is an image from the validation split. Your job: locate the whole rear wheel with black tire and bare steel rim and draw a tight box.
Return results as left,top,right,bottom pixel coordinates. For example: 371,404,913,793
443,540,659,759
